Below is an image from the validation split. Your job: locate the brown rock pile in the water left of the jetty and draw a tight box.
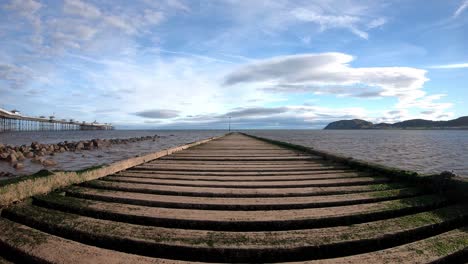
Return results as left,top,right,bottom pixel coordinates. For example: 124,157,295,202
0,135,160,177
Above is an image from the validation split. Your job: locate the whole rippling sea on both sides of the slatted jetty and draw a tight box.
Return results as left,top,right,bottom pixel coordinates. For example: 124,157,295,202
0,130,468,176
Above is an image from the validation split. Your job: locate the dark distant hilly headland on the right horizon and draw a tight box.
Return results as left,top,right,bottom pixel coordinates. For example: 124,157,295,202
324,116,468,129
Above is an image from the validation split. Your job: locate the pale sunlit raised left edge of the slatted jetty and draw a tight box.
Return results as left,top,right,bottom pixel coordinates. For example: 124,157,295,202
0,135,224,209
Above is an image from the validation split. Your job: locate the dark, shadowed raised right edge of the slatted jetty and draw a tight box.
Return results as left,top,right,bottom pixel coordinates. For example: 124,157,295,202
242,133,468,201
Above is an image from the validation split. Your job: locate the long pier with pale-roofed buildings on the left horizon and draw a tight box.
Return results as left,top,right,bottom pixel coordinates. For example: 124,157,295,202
0,109,114,132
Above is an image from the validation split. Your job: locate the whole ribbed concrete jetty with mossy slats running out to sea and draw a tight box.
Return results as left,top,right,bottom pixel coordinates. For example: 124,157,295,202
0,133,468,263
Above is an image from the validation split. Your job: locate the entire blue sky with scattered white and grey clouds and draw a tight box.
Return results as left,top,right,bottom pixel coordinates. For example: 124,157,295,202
0,0,468,129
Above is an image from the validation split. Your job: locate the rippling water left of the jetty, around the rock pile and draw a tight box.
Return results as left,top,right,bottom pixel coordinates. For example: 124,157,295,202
0,130,226,175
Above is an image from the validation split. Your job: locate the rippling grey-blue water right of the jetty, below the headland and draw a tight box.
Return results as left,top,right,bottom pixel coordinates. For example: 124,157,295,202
245,130,468,176
